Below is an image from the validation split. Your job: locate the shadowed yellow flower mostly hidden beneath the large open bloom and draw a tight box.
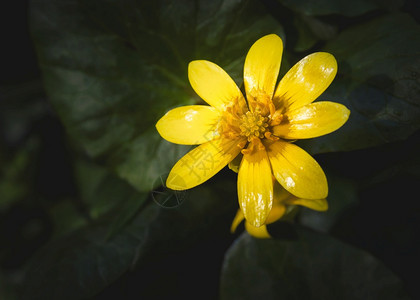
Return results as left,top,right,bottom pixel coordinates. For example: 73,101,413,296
230,179,328,239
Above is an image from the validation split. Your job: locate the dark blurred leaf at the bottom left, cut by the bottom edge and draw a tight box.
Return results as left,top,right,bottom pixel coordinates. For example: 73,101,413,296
22,208,156,299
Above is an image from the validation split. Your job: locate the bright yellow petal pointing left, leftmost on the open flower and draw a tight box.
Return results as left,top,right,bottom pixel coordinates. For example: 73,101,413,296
156,105,220,145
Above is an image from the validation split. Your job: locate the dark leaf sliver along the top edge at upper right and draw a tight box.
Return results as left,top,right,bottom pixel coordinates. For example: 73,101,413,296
277,0,404,17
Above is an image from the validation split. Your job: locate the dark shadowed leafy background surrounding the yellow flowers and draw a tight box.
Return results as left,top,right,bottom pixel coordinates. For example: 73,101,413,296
0,0,420,299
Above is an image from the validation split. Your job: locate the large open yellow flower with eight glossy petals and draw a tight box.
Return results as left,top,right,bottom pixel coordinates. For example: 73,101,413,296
156,34,350,227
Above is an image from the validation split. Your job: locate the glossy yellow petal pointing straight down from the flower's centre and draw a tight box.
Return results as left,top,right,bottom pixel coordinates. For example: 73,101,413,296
238,145,273,227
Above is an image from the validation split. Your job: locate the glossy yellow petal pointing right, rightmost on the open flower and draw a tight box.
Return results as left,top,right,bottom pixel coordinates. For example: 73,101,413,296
273,101,350,139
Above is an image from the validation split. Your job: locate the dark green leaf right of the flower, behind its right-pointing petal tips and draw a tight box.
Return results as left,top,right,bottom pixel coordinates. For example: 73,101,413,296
299,14,420,154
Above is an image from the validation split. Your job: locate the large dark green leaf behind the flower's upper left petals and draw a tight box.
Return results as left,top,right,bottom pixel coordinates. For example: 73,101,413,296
31,0,282,191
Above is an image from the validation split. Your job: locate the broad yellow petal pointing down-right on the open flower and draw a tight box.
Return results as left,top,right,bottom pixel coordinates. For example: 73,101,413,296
267,141,328,199
